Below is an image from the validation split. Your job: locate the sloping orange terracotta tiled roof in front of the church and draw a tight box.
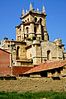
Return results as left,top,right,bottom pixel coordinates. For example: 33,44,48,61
24,60,66,74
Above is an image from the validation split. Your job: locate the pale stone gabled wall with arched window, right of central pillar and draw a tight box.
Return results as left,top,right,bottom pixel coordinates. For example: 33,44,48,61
41,41,63,60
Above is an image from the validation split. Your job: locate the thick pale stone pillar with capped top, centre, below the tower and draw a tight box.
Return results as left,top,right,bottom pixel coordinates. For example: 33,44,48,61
32,40,41,65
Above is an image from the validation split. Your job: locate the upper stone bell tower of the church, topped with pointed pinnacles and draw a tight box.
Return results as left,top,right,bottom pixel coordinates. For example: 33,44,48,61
16,3,49,41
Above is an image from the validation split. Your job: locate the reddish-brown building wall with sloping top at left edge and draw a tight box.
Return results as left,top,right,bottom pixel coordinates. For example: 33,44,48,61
0,49,11,76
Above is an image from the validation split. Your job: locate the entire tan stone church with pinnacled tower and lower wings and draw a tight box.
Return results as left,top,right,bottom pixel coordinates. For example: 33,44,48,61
0,4,66,66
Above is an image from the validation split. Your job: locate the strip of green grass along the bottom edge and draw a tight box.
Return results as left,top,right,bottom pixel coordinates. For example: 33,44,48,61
0,92,66,99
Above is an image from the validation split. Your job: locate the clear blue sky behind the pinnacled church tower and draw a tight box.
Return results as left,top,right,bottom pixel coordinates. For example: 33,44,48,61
0,0,66,45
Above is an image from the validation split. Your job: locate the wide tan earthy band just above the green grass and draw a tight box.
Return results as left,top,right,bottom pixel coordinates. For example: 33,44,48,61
0,78,66,92
